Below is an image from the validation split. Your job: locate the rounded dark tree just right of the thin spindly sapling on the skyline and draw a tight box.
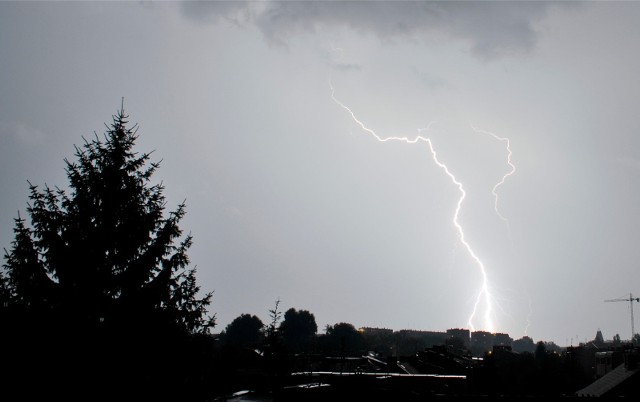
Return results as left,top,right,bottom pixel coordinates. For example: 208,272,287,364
279,308,318,352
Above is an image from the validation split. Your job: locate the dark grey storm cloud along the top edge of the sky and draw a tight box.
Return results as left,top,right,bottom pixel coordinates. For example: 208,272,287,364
182,1,565,59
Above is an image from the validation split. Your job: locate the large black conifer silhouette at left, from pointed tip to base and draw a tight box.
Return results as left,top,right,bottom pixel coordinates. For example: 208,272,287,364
0,109,214,402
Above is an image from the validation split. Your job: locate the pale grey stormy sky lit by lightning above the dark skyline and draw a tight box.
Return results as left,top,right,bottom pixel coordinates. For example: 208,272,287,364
0,1,640,346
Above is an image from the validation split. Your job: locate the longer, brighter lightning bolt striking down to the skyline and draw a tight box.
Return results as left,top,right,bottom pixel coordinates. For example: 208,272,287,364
329,82,495,332
